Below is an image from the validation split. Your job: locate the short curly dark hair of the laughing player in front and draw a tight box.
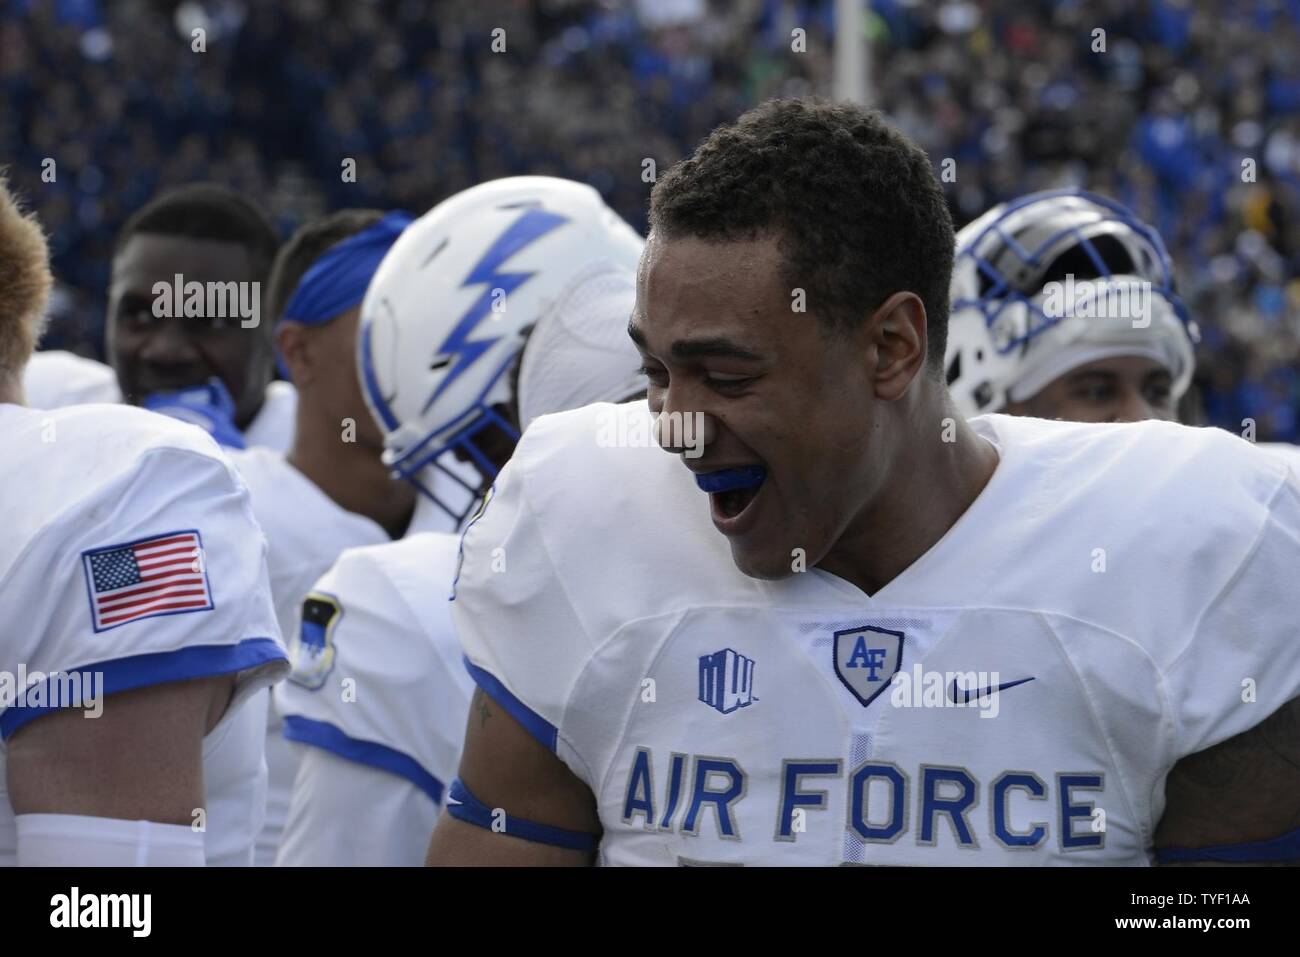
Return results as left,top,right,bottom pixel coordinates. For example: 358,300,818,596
650,98,956,373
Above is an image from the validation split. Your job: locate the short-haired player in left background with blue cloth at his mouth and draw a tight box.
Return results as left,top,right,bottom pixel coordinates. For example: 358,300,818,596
27,183,295,451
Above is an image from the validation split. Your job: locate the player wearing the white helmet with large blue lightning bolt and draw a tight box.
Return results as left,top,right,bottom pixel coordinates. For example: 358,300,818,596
276,177,644,866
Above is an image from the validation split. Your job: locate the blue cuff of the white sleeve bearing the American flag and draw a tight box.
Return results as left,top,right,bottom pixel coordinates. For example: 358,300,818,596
0,638,287,741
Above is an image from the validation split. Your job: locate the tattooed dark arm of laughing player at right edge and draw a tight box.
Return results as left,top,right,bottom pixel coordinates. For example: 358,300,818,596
1156,698,1300,866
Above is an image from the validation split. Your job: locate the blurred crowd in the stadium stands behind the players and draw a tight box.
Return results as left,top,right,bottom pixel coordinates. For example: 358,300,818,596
0,0,1300,442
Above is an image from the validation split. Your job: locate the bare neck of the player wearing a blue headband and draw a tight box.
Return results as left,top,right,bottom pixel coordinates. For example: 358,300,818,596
285,407,415,538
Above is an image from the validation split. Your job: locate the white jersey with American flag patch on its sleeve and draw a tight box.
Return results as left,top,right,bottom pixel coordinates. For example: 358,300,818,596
0,404,289,865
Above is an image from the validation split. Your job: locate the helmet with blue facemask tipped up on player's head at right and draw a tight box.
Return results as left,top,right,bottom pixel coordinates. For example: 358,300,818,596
944,189,1200,416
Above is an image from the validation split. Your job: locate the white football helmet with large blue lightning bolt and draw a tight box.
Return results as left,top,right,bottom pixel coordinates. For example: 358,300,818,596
358,177,644,524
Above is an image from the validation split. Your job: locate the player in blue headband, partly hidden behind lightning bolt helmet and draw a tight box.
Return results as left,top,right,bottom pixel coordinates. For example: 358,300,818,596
230,209,415,866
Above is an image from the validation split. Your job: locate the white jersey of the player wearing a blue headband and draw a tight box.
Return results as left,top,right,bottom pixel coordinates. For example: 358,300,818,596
229,449,389,867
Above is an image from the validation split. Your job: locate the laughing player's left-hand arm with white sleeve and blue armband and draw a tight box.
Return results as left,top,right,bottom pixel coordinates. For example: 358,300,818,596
428,428,603,866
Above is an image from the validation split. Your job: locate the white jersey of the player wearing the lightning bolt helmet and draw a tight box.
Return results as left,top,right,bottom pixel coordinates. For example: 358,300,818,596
276,532,473,866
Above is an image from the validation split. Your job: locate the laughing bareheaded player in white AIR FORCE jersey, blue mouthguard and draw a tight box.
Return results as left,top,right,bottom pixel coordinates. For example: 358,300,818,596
429,100,1300,865
